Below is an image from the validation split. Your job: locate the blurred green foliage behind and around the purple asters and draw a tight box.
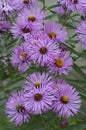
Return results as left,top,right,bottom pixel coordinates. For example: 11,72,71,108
0,0,86,130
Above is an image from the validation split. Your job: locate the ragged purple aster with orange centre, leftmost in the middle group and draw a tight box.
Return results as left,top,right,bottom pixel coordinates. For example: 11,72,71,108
11,45,31,72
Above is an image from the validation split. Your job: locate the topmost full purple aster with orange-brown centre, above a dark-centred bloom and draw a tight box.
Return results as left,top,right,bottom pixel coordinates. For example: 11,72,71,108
19,7,46,25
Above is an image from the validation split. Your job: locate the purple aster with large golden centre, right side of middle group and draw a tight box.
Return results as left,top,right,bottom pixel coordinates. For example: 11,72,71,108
48,51,73,75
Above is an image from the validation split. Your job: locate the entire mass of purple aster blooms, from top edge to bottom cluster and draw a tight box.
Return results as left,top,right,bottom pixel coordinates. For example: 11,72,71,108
0,0,86,128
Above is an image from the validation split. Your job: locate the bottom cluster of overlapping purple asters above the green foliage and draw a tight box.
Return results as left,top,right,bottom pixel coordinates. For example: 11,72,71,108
6,72,81,125
